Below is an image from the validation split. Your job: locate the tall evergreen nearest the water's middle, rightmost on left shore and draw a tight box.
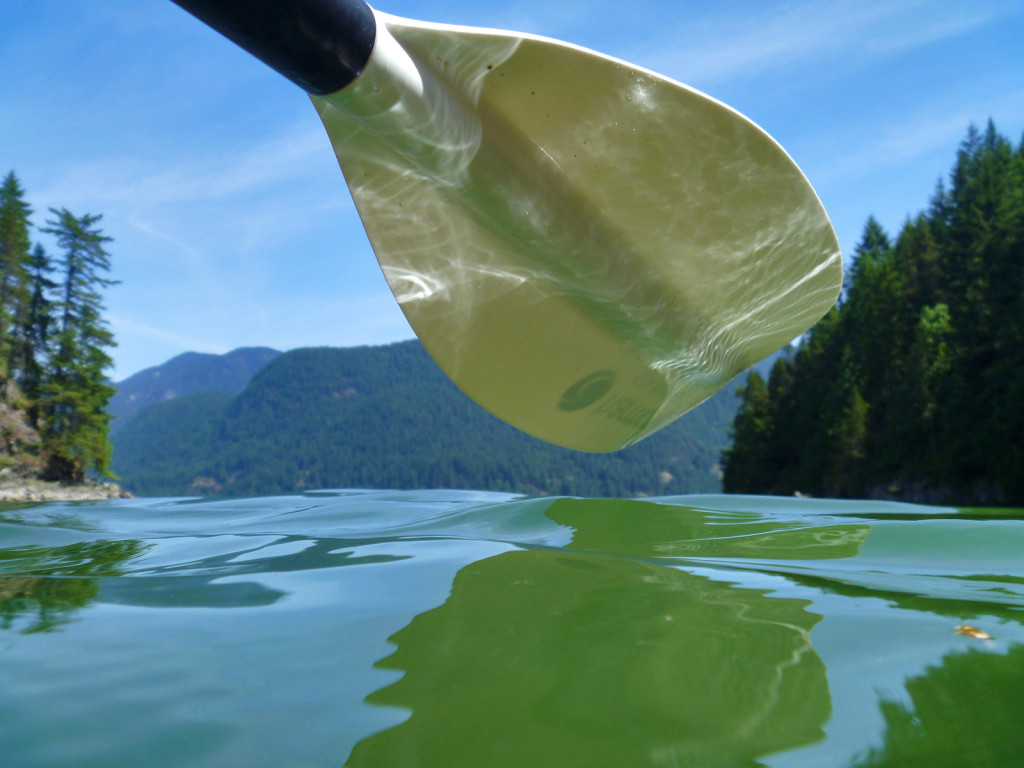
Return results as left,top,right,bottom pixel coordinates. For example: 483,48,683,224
40,209,116,481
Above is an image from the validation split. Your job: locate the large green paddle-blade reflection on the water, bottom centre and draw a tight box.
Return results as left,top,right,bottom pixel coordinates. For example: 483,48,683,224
349,550,830,768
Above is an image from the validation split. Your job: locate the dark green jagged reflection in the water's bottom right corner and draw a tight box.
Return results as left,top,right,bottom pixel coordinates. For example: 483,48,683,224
858,645,1024,768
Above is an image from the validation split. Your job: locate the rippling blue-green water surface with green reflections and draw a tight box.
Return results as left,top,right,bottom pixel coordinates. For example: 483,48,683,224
0,492,1024,768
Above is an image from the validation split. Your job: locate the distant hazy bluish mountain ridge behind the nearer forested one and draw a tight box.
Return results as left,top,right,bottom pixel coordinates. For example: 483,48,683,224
109,347,281,432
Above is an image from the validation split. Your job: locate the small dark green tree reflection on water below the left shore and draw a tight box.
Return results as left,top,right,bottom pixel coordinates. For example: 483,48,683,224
0,540,145,633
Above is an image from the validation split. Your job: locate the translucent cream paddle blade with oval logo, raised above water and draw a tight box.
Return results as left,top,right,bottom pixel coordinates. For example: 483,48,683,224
313,13,842,452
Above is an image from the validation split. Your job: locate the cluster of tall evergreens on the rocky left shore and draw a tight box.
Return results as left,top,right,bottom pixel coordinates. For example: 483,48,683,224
0,171,116,482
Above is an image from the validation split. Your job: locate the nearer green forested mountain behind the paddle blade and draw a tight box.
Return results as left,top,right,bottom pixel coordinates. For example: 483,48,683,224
113,341,753,497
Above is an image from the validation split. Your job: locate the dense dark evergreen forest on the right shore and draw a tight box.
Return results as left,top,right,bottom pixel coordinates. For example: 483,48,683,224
722,122,1024,505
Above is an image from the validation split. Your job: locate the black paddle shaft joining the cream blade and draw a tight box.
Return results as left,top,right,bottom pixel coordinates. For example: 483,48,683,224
172,0,377,96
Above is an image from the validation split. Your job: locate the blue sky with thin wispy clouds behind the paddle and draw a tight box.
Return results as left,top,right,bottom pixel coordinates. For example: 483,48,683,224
0,0,1024,379
